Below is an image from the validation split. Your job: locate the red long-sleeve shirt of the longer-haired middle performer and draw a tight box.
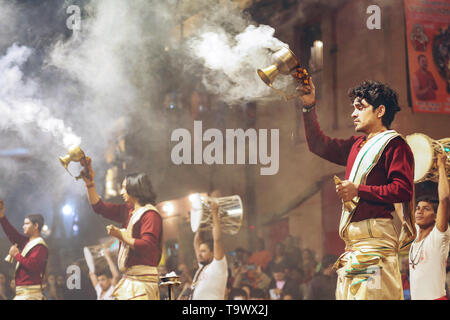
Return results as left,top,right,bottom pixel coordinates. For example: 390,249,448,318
92,199,162,267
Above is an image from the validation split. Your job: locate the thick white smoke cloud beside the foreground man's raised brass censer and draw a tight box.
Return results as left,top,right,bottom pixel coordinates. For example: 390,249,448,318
188,9,292,104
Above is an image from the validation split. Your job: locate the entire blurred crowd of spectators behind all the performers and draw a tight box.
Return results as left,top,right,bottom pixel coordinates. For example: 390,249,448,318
0,232,450,300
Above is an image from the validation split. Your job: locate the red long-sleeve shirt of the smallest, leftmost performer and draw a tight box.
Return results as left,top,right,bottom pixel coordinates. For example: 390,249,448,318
0,217,48,286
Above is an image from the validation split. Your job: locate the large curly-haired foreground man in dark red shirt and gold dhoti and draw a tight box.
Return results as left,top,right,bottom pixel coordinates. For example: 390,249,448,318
297,80,415,300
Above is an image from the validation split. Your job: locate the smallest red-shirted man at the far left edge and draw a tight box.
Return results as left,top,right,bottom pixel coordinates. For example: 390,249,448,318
0,199,48,300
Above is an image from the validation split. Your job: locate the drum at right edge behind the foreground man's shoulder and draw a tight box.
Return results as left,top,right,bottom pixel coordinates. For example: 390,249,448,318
406,133,450,183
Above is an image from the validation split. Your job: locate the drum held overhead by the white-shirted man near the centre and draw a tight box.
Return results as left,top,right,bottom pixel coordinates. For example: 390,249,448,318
190,193,244,235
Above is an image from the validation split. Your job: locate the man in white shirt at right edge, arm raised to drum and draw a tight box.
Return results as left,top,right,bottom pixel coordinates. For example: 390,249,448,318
409,154,450,300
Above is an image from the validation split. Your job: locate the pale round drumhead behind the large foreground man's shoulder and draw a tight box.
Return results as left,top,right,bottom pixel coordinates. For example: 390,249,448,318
406,133,434,182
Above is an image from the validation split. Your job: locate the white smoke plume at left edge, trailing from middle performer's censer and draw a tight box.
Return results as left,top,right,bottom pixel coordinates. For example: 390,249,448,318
0,44,81,148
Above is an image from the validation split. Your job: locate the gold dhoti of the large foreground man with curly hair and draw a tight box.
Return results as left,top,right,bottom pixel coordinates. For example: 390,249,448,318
335,219,403,300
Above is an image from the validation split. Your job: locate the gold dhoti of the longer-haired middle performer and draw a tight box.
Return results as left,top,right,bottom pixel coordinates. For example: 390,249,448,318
112,265,159,300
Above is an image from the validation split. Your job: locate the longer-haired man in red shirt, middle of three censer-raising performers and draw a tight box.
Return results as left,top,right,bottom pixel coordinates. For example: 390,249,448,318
83,158,162,300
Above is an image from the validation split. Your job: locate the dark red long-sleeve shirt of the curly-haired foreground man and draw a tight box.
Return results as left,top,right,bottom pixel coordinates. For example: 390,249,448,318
303,110,414,222
